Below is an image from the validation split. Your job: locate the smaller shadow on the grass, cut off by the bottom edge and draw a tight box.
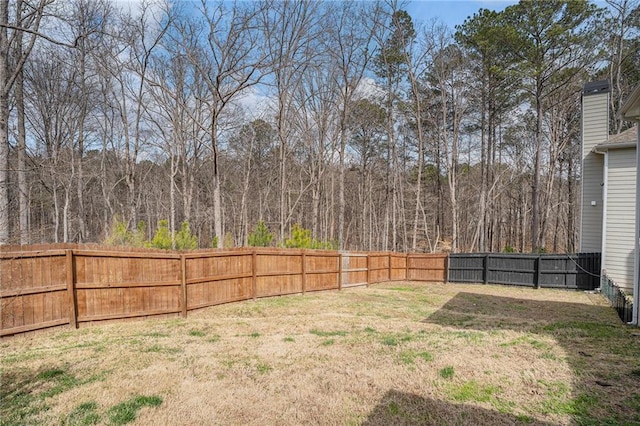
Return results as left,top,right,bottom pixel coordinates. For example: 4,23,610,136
362,390,552,426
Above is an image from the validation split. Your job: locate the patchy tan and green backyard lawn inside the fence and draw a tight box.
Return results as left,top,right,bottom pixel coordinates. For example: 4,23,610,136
0,282,640,425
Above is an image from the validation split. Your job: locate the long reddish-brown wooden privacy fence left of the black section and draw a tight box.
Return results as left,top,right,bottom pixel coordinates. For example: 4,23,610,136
0,246,447,336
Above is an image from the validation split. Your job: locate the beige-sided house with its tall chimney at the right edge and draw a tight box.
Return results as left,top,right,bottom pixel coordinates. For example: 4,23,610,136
580,81,638,312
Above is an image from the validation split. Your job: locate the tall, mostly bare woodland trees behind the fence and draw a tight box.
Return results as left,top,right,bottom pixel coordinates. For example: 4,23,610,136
0,0,640,252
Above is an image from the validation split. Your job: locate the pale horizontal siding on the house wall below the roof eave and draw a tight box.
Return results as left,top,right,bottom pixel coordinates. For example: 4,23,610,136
603,148,636,293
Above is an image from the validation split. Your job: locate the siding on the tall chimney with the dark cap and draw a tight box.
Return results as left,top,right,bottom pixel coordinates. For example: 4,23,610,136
580,93,609,252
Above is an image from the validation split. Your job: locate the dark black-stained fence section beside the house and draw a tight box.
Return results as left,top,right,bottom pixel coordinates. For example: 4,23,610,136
447,253,600,290
